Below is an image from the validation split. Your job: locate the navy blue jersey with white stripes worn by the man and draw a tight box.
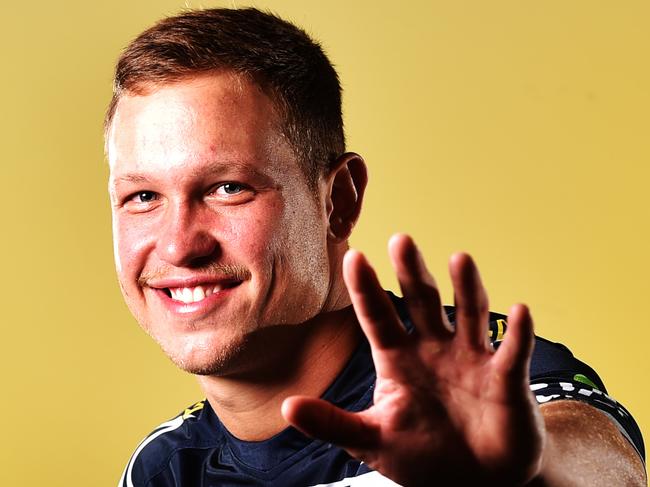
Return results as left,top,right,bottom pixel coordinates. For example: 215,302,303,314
119,297,645,487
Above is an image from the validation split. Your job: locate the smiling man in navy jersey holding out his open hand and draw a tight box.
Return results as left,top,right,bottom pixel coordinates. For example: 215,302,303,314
106,9,645,487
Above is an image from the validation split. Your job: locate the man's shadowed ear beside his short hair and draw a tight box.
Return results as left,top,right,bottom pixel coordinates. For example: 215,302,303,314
326,152,368,242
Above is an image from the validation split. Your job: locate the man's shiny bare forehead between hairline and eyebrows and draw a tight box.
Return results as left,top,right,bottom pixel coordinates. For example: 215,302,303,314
107,72,295,182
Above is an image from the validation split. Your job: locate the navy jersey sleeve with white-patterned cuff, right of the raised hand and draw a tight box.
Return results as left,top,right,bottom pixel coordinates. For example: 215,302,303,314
489,313,645,463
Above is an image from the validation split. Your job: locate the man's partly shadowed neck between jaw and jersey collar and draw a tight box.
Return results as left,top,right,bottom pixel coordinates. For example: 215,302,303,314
199,306,361,441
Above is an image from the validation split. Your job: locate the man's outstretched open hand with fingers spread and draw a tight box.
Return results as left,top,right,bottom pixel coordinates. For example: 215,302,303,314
282,235,545,487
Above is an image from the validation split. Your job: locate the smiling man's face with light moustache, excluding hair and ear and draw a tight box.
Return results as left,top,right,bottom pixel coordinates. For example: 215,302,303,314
108,73,330,373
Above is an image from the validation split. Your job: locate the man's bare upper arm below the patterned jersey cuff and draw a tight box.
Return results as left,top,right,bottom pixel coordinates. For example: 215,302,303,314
530,401,647,487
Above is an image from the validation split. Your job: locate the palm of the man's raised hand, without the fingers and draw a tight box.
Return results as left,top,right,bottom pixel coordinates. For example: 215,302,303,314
368,328,539,485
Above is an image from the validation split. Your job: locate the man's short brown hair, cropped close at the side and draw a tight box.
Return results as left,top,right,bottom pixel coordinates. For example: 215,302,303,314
104,8,345,185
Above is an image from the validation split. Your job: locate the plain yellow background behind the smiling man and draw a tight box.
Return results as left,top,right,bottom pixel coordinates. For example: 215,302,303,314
0,0,650,487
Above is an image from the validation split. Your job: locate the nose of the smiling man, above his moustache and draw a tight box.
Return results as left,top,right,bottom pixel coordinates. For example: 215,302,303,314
156,202,219,267
